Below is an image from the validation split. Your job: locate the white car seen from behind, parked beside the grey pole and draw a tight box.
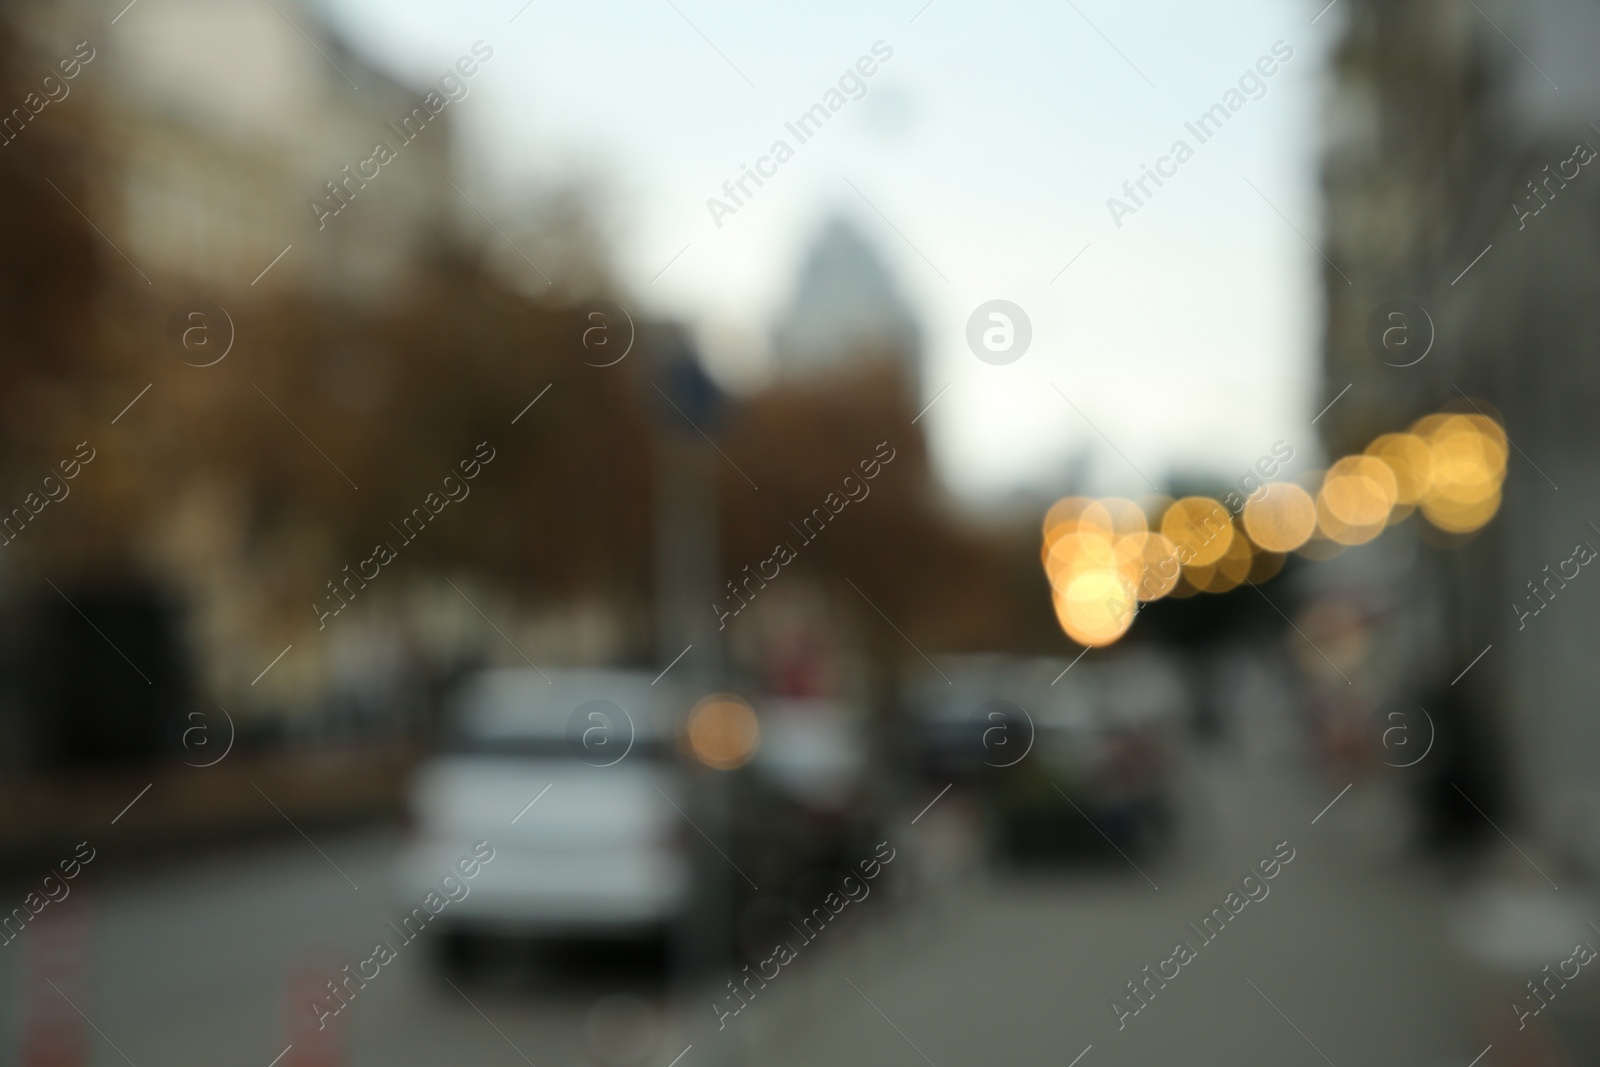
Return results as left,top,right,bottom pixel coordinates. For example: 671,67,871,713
400,669,693,936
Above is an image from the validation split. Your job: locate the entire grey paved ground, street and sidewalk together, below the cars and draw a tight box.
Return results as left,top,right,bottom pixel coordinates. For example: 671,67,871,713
0,751,1493,1067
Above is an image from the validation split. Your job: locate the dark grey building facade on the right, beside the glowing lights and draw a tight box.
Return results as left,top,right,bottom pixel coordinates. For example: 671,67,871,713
1318,0,1600,870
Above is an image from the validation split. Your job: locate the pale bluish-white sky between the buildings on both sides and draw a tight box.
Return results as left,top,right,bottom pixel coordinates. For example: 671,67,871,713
325,0,1342,504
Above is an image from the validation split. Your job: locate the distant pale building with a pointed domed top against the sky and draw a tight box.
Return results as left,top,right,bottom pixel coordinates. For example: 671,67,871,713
773,219,922,397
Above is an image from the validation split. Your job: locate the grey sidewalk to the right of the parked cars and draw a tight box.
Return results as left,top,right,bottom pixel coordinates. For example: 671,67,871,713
749,764,1486,1067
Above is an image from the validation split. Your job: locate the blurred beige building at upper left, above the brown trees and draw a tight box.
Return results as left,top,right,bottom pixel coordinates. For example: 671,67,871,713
24,0,457,301
